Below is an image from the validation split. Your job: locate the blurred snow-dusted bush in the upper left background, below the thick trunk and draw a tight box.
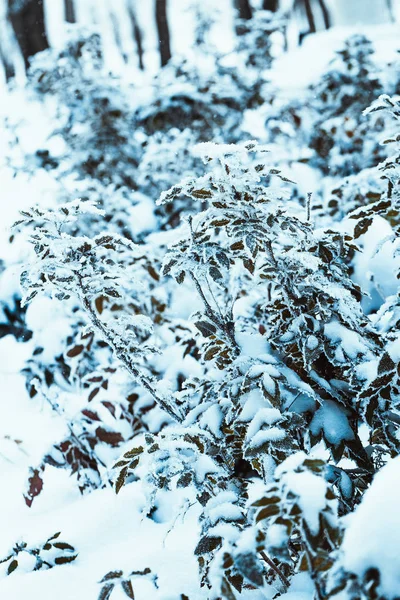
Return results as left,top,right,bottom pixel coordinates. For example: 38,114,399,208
28,29,140,188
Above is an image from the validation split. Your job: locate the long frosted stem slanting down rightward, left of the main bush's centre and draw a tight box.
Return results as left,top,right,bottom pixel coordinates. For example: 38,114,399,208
79,281,183,423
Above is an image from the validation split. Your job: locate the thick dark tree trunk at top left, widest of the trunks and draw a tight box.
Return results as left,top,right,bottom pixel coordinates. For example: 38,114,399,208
8,0,49,68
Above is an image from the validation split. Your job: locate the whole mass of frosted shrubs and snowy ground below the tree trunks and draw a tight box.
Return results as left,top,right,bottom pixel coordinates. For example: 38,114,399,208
0,2,400,600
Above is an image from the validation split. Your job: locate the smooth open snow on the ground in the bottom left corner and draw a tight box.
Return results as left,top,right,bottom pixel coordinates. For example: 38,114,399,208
1,481,204,600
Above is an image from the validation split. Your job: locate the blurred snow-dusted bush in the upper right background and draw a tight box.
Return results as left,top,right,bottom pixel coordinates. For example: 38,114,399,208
266,35,385,180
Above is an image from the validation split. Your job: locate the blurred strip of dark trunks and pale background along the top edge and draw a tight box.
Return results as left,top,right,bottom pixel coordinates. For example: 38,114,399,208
0,0,400,81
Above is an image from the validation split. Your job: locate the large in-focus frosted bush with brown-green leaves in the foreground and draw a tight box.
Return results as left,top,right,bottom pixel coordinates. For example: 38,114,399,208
15,142,397,599
